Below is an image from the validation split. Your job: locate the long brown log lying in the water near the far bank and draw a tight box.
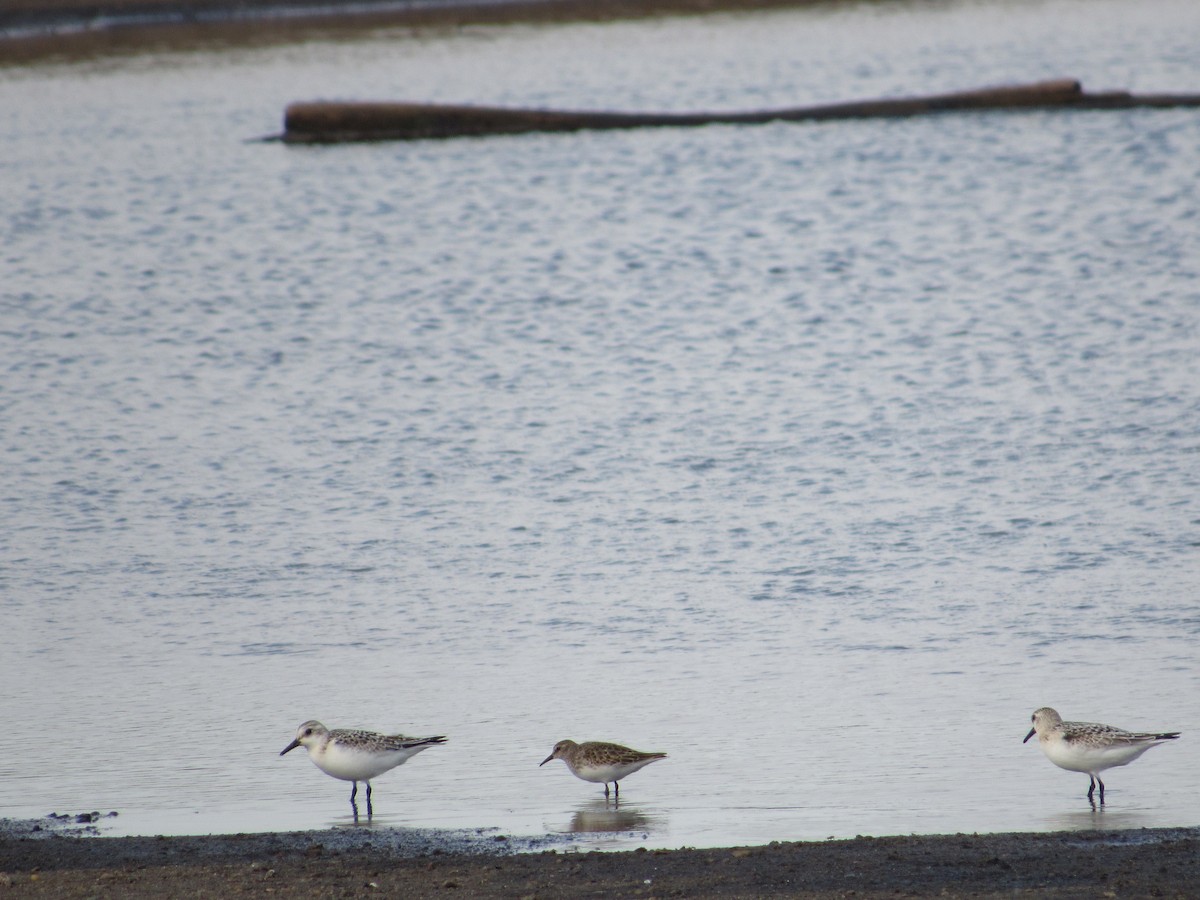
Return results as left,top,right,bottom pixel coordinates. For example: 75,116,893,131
282,78,1200,144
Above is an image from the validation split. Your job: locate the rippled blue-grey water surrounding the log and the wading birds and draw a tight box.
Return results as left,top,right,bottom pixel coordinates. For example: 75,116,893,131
0,0,1200,847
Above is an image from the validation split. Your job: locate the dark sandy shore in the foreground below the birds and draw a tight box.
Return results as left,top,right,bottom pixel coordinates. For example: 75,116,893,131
0,823,1200,898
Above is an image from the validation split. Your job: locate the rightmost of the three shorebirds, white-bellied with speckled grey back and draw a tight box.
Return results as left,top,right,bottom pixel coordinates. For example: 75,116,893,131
1021,707,1180,806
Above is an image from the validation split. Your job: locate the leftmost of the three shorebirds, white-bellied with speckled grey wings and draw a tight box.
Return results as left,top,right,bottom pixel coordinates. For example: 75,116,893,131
280,719,446,816
